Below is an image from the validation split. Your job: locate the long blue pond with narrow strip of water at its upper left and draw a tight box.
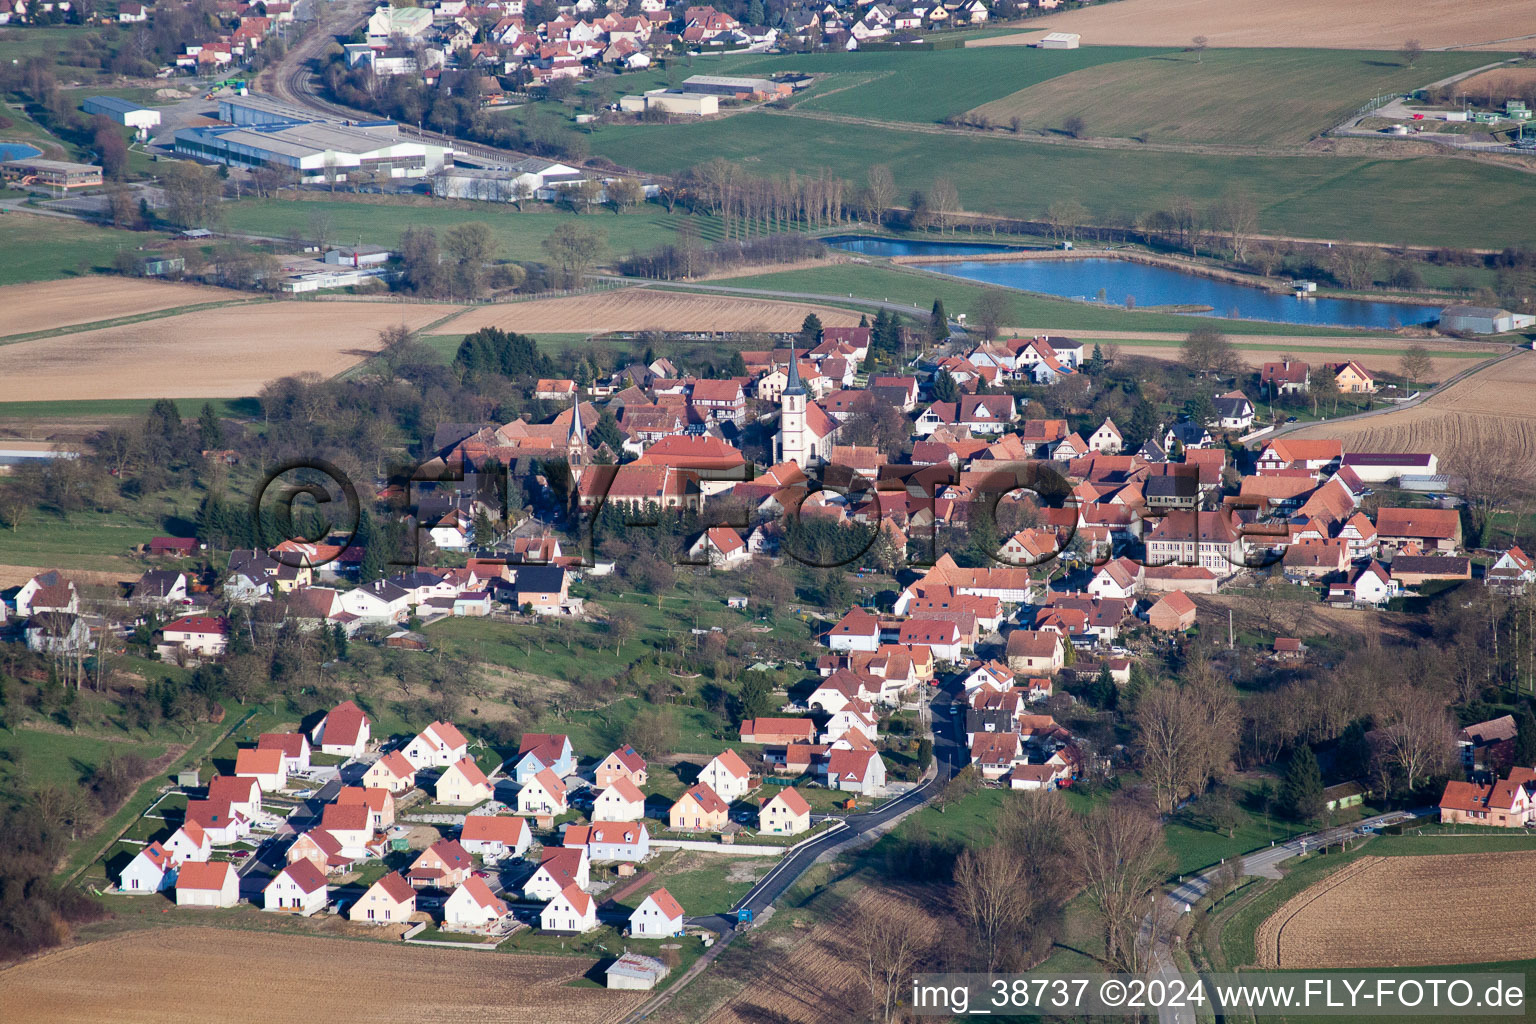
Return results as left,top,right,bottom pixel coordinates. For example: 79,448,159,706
826,238,1439,329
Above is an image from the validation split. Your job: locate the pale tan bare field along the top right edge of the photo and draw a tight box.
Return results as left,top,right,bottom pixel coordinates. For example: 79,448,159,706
966,0,1536,51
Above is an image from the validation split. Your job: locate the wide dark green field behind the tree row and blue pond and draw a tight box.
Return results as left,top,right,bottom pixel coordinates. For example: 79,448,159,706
593,112,1530,247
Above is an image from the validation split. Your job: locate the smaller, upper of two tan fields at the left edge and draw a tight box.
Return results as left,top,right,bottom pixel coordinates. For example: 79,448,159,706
0,275,252,336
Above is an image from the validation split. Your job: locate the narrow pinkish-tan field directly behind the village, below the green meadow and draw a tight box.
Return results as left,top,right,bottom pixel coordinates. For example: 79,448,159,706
438,289,859,335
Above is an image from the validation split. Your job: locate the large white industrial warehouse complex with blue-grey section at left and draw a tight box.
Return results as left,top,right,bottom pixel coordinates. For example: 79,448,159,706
175,97,452,183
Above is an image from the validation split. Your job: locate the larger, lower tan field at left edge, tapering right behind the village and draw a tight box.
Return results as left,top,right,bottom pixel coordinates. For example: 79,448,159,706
0,302,458,402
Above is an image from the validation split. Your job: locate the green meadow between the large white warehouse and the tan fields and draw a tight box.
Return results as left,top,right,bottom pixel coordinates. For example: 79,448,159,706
223,197,720,259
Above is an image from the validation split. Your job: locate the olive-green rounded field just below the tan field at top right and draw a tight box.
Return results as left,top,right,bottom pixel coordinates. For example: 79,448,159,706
970,48,1488,144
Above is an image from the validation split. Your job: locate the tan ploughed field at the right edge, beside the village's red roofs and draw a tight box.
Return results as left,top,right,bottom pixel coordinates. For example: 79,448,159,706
1293,352,1536,485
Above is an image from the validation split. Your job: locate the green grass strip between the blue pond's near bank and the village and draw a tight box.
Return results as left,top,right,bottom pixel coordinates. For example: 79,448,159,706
697,263,1370,336
